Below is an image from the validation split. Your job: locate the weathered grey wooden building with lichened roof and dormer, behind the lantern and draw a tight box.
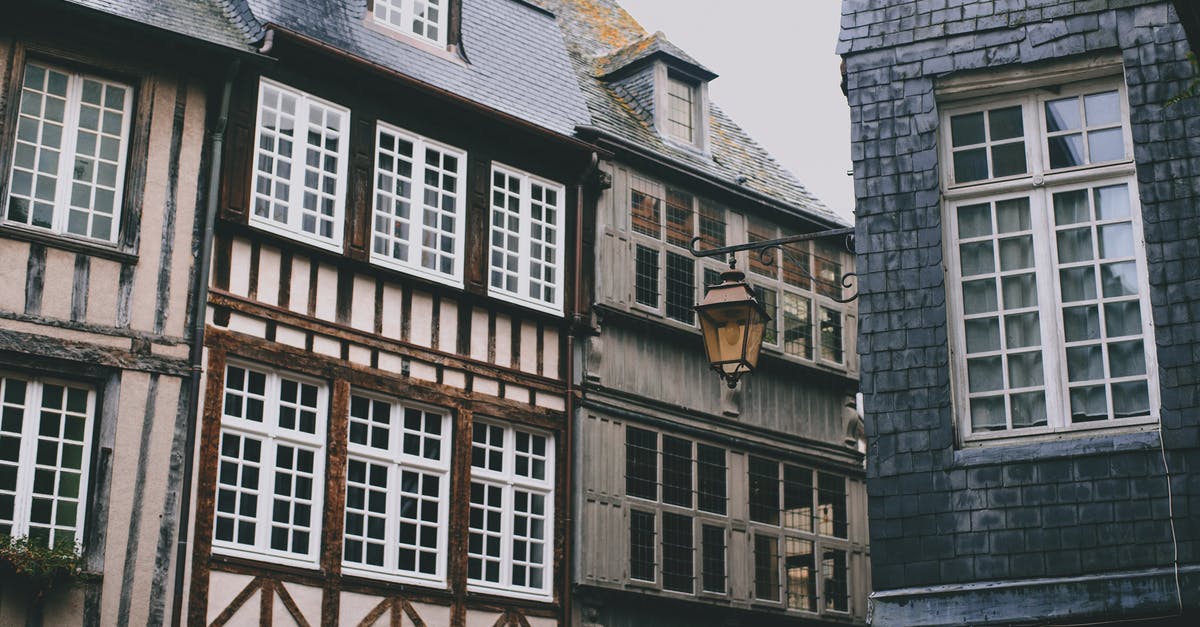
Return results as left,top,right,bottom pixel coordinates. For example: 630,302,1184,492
541,0,870,626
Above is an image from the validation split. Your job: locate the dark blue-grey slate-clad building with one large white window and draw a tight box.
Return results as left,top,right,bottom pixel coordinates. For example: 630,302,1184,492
838,0,1200,625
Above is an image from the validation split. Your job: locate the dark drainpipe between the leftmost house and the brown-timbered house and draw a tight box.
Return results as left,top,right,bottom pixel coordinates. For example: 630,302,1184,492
170,59,241,627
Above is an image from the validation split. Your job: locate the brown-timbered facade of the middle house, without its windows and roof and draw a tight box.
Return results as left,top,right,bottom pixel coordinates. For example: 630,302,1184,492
187,31,592,626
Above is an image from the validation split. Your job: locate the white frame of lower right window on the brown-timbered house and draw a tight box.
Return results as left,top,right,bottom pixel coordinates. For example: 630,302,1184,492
464,418,557,601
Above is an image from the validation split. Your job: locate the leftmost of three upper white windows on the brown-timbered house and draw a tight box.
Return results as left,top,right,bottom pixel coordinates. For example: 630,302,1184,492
250,78,350,251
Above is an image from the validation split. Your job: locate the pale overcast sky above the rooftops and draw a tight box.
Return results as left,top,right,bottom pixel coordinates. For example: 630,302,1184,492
617,0,854,219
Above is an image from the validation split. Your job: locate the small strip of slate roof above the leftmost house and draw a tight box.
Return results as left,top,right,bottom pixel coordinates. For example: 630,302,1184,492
64,0,257,52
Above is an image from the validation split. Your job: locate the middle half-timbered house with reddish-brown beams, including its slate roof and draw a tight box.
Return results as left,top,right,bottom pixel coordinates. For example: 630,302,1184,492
186,0,593,627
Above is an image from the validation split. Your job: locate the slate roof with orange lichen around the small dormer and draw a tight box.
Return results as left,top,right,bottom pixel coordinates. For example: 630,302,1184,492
534,0,846,225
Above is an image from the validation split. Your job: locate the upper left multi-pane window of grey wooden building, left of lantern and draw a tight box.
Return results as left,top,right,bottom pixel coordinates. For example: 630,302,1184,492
630,178,725,324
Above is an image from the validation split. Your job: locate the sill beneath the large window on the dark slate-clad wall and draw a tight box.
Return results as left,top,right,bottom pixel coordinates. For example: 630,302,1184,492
953,422,1160,467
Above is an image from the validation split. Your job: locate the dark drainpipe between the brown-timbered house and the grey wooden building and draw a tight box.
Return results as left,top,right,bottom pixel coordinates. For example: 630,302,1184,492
563,153,600,625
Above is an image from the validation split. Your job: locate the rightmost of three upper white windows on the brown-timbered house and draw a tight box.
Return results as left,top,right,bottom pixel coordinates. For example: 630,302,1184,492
487,163,566,314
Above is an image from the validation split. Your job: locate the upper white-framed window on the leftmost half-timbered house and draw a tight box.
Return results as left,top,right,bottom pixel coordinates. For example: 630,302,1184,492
4,60,133,244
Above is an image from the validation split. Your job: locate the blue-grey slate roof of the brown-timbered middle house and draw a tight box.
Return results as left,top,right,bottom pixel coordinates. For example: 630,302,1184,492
238,0,588,136
